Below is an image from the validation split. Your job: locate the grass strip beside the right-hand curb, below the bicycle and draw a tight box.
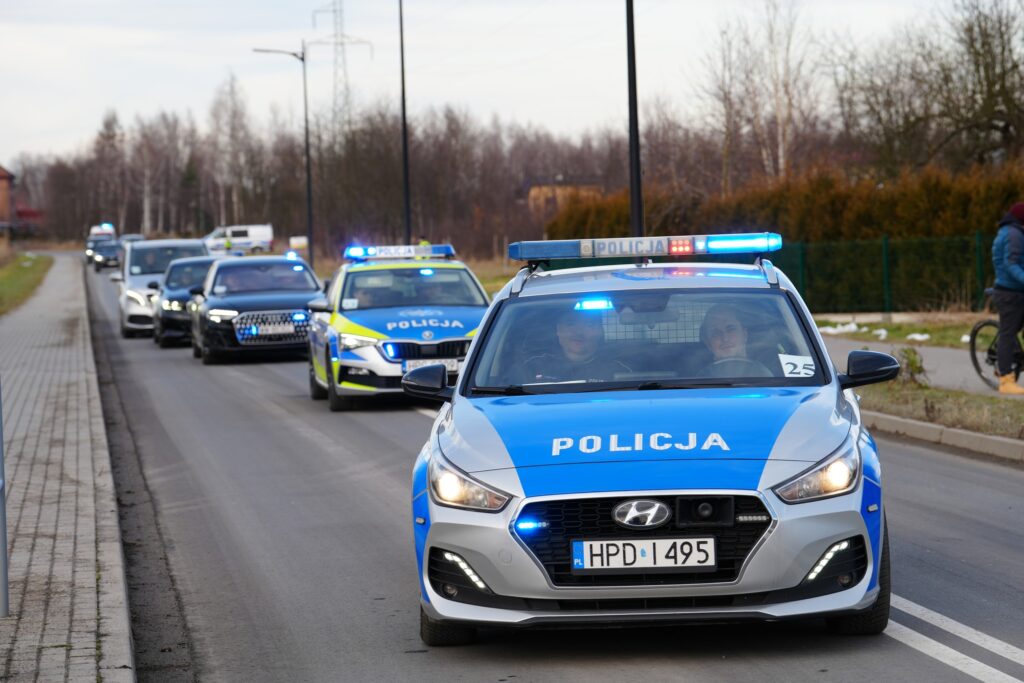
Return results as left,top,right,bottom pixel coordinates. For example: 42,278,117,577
856,380,1024,439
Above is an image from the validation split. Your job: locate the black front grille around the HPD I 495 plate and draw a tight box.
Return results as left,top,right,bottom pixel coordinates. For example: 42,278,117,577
520,496,771,587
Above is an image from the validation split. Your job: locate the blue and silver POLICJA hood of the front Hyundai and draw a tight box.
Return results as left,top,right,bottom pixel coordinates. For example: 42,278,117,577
438,385,857,496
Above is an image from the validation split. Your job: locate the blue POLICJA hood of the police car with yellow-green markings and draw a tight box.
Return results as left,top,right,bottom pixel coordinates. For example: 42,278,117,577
341,306,487,340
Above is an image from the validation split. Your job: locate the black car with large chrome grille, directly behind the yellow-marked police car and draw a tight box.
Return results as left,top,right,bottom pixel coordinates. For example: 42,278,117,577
188,256,319,365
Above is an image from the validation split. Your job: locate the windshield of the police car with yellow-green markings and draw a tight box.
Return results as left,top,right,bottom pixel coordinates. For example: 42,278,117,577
341,266,487,310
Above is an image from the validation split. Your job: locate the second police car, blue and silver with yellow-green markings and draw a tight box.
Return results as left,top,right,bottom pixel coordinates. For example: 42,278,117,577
308,245,487,411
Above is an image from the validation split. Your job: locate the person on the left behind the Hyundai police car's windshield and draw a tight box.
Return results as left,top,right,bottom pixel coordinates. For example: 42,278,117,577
517,310,631,384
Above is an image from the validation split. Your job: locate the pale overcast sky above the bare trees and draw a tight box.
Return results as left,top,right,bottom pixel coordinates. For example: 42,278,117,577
0,0,934,164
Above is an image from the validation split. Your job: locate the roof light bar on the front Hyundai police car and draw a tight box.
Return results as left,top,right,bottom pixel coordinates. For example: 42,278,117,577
509,232,782,261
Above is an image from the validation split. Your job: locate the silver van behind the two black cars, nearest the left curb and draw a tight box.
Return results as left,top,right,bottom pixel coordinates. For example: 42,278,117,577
111,240,207,338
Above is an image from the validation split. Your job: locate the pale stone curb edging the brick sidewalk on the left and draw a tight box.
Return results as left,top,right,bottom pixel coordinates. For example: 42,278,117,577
81,260,135,682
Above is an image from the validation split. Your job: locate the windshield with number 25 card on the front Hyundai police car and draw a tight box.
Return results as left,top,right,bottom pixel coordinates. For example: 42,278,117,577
471,290,824,393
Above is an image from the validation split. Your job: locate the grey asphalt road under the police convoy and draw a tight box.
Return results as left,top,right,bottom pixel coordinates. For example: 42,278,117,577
81,272,1024,683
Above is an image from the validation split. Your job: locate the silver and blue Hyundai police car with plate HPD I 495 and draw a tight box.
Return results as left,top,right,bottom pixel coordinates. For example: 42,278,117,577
403,233,899,645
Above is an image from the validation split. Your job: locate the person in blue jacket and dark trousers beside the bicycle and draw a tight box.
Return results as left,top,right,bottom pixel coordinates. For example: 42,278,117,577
992,203,1024,395
